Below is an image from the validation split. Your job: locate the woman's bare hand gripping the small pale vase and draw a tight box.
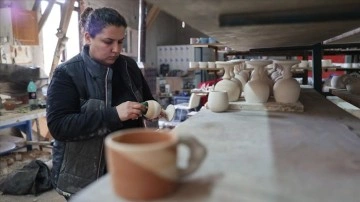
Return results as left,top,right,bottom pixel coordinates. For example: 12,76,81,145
116,101,146,121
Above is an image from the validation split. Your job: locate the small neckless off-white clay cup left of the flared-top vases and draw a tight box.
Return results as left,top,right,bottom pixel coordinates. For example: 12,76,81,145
207,91,229,112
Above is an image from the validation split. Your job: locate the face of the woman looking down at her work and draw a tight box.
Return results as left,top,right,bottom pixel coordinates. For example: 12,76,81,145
85,25,125,66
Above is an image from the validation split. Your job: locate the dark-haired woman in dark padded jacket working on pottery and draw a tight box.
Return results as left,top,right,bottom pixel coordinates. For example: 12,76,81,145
47,8,154,198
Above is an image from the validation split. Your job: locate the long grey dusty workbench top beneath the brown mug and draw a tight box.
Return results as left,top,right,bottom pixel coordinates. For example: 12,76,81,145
72,89,360,202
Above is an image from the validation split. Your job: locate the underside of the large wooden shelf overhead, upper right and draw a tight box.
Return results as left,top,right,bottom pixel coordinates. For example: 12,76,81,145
144,0,360,51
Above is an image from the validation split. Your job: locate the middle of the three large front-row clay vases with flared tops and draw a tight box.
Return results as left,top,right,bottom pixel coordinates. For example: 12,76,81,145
244,60,272,103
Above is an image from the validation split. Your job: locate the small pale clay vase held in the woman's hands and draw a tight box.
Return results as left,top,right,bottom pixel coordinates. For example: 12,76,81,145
142,100,175,121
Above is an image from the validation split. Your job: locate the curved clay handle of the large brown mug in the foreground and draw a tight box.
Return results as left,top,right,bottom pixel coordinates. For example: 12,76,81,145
179,136,207,177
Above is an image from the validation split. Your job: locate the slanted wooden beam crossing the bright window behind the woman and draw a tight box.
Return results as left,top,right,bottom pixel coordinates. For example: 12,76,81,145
49,0,76,78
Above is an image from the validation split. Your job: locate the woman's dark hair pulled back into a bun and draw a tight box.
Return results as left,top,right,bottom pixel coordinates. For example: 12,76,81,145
79,7,127,37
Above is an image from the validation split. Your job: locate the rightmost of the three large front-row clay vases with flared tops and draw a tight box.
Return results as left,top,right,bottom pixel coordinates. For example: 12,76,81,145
273,60,300,103
